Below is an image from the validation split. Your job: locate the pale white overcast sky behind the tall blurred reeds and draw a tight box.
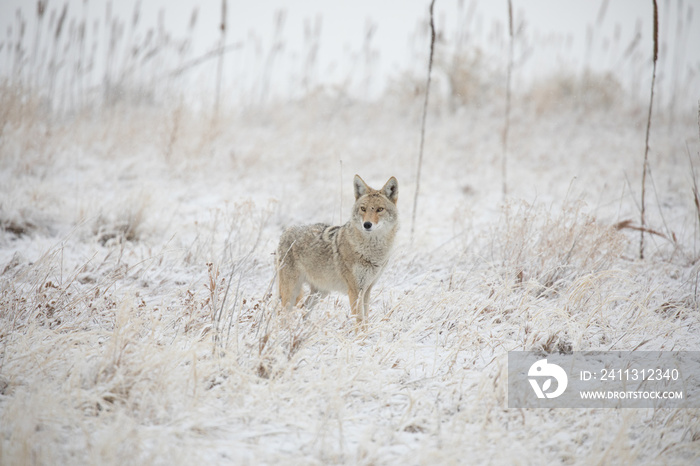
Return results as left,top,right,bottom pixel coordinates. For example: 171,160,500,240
0,0,700,103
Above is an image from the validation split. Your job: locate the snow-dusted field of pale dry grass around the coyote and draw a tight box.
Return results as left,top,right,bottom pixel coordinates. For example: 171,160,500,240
0,82,700,464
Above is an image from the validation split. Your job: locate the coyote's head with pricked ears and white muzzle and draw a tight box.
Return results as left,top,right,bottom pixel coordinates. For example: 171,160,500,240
352,175,399,233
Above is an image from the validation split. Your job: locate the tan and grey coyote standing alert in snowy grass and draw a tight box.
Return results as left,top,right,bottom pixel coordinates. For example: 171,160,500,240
277,175,399,326
